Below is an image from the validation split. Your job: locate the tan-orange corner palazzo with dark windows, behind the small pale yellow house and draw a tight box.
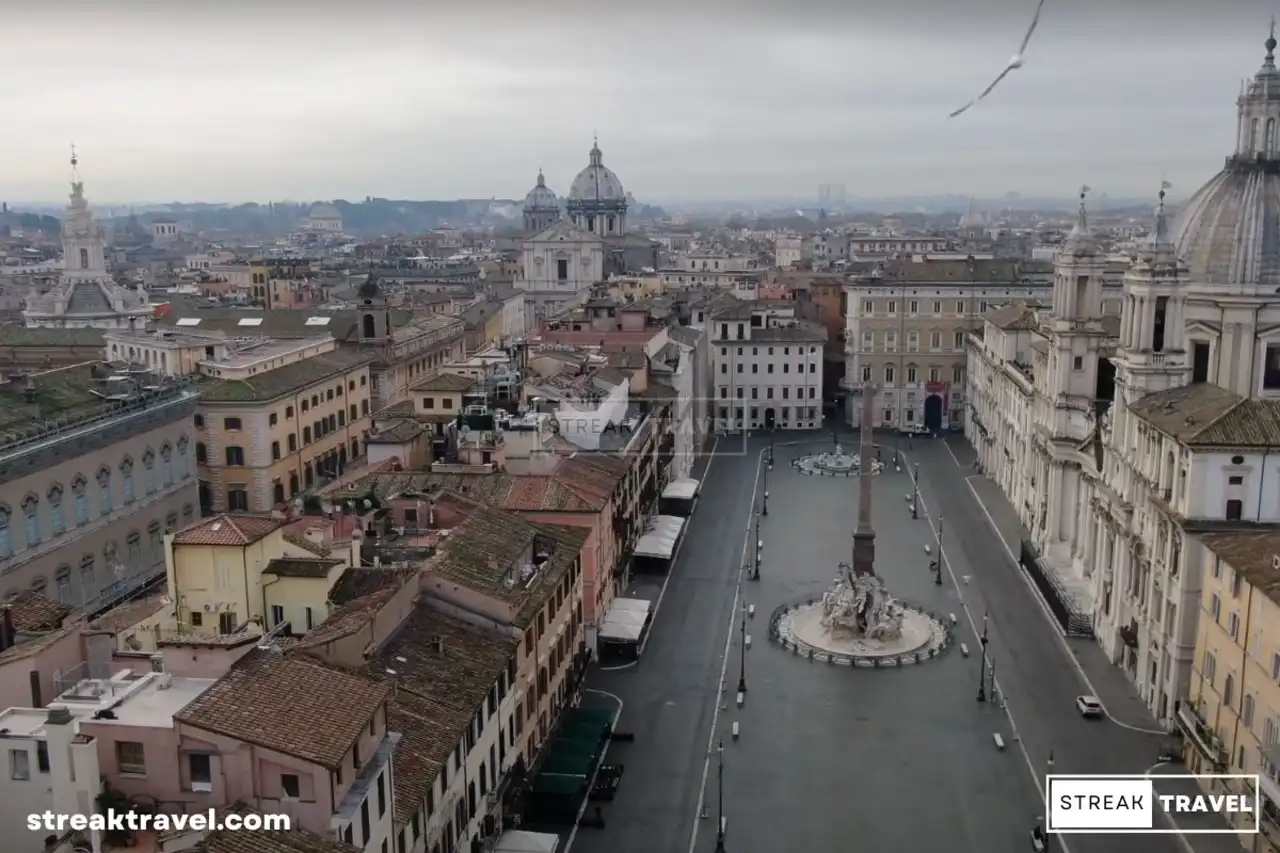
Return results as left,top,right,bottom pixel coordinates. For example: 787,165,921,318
196,350,374,512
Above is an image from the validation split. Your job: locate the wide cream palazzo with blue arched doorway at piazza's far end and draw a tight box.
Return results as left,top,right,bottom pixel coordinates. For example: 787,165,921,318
842,256,1120,430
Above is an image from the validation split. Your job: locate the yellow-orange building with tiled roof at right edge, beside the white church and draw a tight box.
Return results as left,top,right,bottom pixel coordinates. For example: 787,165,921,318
1178,530,1280,850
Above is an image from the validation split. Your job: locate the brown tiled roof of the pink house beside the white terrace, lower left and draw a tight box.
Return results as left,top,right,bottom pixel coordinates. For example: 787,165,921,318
174,649,390,770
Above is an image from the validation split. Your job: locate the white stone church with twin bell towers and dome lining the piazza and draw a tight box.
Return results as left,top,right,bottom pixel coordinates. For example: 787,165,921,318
965,29,1280,730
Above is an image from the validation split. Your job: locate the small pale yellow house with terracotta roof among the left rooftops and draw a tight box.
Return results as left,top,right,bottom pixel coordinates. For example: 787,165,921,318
166,514,352,635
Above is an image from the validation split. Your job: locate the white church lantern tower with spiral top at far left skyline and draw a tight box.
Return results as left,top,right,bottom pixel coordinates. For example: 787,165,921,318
23,166,152,329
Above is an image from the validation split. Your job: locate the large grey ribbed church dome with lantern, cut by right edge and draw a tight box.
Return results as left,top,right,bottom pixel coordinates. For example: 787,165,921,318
1172,32,1280,293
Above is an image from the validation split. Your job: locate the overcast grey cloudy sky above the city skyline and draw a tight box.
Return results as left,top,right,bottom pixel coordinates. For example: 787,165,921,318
0,0,1275,202
